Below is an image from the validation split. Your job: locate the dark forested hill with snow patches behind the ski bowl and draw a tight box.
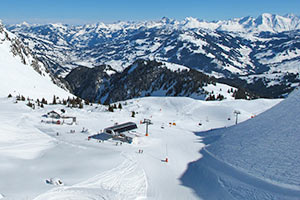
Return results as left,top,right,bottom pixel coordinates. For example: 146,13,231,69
65,59,248,104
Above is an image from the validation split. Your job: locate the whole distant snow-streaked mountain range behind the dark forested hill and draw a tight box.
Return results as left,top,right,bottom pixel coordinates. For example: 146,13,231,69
8,14,300,97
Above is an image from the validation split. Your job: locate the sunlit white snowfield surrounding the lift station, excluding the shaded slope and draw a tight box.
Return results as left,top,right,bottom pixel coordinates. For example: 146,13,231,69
0,94,281,200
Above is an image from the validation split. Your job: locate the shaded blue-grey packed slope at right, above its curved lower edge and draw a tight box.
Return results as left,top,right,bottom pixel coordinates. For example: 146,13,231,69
208,87,300,186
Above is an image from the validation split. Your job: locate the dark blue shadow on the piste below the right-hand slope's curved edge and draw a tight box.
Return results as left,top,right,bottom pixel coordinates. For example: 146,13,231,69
180,128,300,200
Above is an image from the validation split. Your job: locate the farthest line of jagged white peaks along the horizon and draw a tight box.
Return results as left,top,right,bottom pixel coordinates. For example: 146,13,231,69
8,13,300,32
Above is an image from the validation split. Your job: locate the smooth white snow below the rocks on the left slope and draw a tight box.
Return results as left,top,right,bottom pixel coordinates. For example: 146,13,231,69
0,25,72,100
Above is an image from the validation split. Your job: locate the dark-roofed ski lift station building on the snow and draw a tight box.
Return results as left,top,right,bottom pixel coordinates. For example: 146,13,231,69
103,122,137,143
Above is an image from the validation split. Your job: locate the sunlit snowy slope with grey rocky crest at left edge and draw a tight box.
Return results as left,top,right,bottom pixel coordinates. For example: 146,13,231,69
0,24,71,100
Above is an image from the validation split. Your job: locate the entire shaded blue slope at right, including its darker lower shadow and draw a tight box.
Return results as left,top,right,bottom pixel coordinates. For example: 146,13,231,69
182,89,300,199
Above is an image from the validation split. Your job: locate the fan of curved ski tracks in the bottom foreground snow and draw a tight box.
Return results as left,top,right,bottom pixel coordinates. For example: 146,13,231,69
34,153,148,200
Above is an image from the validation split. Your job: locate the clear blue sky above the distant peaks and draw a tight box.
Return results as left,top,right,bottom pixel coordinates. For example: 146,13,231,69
0,0,300,24
